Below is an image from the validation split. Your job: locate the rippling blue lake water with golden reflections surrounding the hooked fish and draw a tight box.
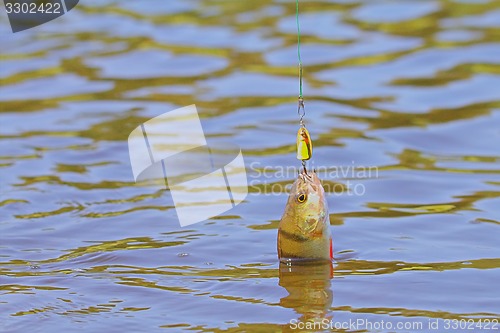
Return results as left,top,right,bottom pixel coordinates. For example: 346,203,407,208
0,0,500,332
